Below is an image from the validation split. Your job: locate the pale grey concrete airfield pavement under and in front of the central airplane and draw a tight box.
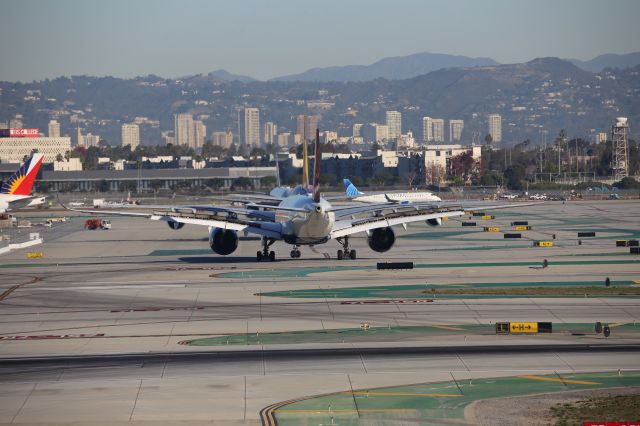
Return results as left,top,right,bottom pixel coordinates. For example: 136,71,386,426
0,201,640,424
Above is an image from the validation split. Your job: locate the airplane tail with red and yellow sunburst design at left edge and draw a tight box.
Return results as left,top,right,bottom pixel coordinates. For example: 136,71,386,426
0,153,45,213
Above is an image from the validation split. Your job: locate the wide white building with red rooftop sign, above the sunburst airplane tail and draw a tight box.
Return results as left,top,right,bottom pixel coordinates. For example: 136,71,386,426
0,129,71,163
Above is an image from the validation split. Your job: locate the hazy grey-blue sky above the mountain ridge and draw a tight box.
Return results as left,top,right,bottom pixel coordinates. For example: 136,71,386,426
0,0,640,81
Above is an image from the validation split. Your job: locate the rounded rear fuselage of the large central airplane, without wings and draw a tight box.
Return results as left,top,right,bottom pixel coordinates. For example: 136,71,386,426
276,195,336,245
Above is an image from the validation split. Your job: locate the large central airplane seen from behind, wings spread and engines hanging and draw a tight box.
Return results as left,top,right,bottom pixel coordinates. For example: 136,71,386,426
61,130,528,261
